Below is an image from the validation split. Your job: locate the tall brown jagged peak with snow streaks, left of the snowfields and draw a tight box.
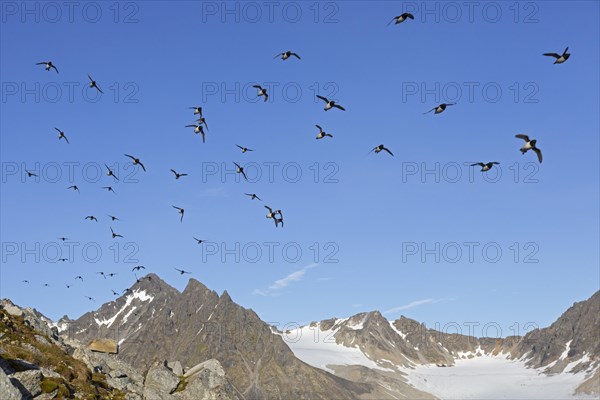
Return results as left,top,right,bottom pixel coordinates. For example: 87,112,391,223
62,274,384,399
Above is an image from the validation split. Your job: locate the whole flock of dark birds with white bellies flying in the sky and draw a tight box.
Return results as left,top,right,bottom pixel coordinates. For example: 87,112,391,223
14,13,570,301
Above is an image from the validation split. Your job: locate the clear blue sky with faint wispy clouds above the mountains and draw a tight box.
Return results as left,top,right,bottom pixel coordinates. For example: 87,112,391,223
0,1,600,335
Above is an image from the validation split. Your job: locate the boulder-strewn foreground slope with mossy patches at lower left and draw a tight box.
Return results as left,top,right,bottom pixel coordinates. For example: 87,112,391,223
0,300,250,400
